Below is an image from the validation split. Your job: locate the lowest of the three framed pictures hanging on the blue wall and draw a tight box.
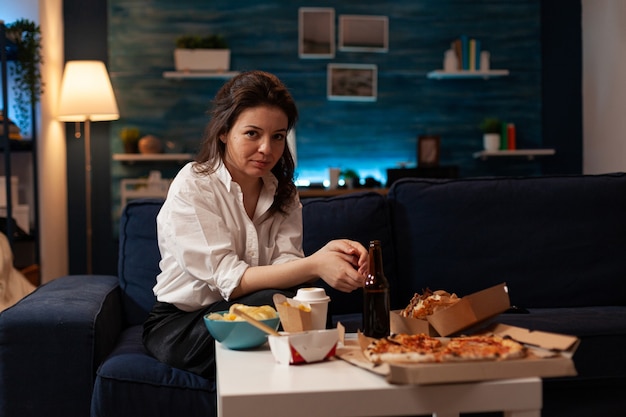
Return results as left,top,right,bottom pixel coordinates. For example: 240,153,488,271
327,64,378,101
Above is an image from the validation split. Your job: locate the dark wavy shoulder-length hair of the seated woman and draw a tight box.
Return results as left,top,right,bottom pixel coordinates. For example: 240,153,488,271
195,71,298,213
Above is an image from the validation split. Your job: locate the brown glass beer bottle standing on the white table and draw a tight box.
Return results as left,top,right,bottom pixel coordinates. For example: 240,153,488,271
363,240,390,339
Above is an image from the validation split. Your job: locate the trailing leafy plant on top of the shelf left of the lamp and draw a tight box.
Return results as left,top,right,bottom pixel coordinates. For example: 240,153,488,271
6,19,44,135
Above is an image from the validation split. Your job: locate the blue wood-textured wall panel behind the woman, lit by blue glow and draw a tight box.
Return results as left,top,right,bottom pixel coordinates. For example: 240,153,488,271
109,0,543,200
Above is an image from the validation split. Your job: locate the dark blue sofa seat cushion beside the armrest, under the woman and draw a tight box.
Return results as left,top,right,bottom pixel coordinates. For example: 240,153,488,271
91,325,217,417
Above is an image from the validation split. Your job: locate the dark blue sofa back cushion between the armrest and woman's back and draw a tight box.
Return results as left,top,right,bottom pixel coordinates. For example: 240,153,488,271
118,199,163,324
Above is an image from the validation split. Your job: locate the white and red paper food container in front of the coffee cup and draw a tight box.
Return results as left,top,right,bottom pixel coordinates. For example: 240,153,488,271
268,329,339,365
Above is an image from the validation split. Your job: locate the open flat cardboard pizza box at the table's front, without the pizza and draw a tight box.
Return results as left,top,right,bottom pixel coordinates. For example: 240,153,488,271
337,324,579,385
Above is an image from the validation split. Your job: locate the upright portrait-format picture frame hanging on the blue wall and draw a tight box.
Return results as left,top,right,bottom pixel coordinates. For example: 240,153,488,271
298,7,335,58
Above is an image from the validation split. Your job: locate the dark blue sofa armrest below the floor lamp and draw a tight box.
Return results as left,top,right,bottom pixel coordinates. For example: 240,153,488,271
0,275,123,417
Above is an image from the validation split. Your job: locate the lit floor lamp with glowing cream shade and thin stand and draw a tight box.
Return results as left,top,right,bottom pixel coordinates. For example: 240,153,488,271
57,61,120,274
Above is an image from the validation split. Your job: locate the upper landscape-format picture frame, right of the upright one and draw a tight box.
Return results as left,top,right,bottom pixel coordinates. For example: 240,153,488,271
339,15,389,52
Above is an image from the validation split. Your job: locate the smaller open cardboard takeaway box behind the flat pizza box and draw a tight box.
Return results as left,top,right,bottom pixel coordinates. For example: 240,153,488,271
390,283,511,336
